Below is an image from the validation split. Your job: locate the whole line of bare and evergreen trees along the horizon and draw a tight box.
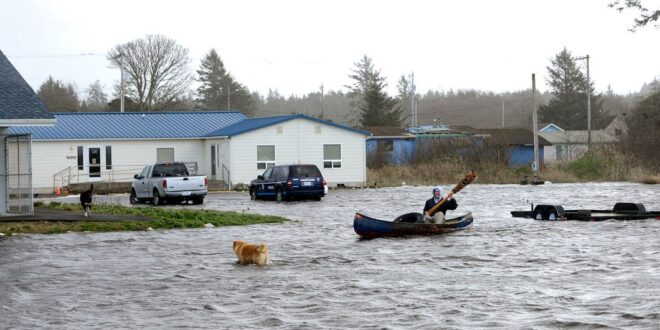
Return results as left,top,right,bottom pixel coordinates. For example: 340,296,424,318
37,35,660,134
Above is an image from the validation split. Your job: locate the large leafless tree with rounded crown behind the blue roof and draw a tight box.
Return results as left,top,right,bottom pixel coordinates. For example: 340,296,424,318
107,35,192,111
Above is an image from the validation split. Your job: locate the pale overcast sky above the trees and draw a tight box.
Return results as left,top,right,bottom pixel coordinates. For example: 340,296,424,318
0,0,660,96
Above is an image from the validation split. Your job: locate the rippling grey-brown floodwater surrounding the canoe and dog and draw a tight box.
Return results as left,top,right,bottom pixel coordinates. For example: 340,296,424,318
0,183,660,329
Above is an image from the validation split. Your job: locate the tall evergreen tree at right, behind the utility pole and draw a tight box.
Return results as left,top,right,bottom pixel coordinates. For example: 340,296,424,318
539,48,608,130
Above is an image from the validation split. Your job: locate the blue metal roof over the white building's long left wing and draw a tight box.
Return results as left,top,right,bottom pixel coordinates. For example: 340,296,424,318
9,111,246,140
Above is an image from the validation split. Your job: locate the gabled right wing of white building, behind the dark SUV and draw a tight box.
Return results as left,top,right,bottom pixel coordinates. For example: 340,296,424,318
206,115,369,187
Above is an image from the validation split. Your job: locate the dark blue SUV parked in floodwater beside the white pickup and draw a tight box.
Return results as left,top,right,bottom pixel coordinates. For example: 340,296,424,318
250,165,328,202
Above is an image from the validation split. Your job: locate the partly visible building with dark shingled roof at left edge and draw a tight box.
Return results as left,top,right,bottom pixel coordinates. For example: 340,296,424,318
0,51,55,216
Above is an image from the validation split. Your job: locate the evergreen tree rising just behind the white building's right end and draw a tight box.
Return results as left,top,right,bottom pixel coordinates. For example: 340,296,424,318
346,55,401,127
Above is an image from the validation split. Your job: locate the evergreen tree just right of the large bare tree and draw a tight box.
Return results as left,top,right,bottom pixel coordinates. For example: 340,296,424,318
197,49,257,116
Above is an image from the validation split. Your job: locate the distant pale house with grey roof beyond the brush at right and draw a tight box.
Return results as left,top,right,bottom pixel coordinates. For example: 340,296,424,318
539,115,628,162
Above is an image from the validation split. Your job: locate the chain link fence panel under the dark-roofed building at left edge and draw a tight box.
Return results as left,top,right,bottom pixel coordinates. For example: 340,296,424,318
5,134,34,215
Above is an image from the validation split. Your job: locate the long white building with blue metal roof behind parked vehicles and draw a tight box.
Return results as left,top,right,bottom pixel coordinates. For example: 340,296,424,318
12,112,369,193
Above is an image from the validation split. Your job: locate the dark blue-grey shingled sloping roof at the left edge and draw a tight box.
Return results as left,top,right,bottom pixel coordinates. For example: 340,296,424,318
0,51,54,120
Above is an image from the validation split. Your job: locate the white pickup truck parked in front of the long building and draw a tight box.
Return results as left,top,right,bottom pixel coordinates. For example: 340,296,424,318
130,162,208,205
